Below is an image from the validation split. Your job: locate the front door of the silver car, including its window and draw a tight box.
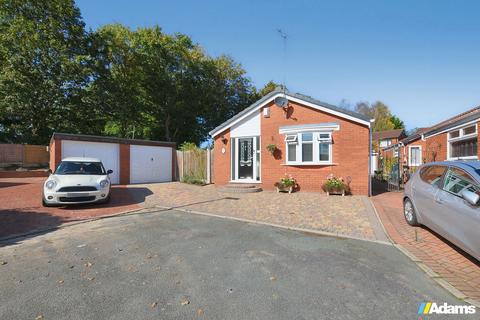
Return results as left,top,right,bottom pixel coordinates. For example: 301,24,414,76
435,167,480,256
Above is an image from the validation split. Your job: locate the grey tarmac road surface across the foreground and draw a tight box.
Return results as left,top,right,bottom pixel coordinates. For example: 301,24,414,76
0,211,474,320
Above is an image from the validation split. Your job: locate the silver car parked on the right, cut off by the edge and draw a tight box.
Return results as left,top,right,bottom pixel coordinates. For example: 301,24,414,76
403,161,480,260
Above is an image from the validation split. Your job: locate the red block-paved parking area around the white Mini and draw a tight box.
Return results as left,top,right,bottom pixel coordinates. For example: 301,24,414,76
0,178,150,238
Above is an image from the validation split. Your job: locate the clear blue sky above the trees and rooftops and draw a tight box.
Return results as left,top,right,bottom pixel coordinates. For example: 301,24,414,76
76,0,480,129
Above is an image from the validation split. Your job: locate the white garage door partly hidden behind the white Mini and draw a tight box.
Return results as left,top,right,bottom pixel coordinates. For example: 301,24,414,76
62,140,120,184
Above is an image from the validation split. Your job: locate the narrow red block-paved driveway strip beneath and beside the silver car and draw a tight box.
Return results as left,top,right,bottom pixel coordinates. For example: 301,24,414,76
372,192,480,302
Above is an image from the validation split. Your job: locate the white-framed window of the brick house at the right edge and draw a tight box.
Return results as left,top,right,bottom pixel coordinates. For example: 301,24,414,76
448,124,478,159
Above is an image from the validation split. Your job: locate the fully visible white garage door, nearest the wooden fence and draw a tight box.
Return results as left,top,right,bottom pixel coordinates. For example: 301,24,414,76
130,145,172,183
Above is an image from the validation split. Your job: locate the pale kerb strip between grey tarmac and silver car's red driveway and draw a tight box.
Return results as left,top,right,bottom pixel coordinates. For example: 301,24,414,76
370,200,480,308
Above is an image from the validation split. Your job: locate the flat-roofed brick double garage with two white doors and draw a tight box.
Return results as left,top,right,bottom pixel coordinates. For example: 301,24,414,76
49,133,176,184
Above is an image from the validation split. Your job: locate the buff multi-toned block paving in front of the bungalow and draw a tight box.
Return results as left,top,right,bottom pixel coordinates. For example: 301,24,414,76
131,182,388,241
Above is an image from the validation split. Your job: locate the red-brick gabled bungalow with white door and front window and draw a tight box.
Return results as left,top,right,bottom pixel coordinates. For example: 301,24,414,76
210,89,371,195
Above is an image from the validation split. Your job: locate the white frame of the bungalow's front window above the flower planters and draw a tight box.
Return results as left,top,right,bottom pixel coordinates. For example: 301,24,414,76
285,131,333,166
